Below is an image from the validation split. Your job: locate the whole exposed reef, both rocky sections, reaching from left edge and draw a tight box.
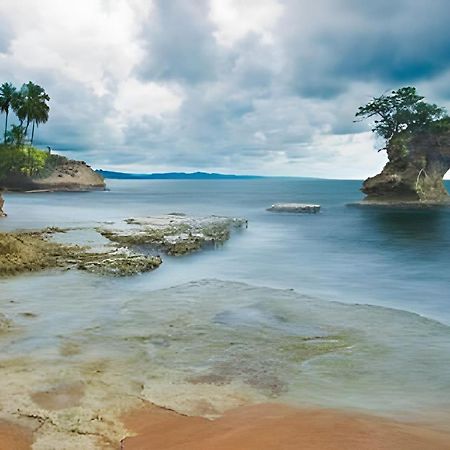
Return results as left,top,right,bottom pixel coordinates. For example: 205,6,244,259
0,214,247,277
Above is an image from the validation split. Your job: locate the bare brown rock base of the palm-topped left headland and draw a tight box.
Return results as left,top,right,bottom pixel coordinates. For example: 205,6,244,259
0,159,105,191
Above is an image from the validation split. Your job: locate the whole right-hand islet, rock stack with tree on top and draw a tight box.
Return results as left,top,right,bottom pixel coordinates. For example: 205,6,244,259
356,87,450,206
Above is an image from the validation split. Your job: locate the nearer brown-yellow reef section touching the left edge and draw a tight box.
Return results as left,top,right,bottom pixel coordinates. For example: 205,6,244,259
0,229,162,276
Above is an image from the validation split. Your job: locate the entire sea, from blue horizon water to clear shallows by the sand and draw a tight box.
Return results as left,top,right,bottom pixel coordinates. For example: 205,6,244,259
0,178,450,428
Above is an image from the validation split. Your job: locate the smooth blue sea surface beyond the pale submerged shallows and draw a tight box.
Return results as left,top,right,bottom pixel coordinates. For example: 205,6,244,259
0,178,450,324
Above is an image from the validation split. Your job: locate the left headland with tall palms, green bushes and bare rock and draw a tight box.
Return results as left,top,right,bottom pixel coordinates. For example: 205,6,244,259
0,81,105,201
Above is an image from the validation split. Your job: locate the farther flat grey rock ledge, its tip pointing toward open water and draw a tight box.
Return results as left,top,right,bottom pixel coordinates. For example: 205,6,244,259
97,213,248,256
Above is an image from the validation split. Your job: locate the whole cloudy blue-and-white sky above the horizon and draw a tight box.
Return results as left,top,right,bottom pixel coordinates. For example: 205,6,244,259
0,0,450,179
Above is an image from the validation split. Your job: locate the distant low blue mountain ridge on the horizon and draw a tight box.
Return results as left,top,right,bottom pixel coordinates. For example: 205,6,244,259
96,169,264,180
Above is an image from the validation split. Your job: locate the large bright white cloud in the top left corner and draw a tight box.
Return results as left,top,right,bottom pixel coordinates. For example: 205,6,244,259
0,0,151,96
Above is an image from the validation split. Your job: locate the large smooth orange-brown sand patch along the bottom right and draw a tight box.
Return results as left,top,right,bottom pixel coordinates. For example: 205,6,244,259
122,404,450,450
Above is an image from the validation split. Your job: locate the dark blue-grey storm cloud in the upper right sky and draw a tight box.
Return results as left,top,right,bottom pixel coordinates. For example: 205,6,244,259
285,0,450,98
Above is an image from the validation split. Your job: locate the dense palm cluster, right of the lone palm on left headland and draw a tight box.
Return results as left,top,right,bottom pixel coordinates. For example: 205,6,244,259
13,81,50,144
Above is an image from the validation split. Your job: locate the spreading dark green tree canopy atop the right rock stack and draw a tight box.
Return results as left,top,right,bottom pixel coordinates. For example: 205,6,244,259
356,86,447,140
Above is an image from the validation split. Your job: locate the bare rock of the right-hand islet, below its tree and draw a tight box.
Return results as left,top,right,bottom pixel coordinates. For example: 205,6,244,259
361,130,450,205
